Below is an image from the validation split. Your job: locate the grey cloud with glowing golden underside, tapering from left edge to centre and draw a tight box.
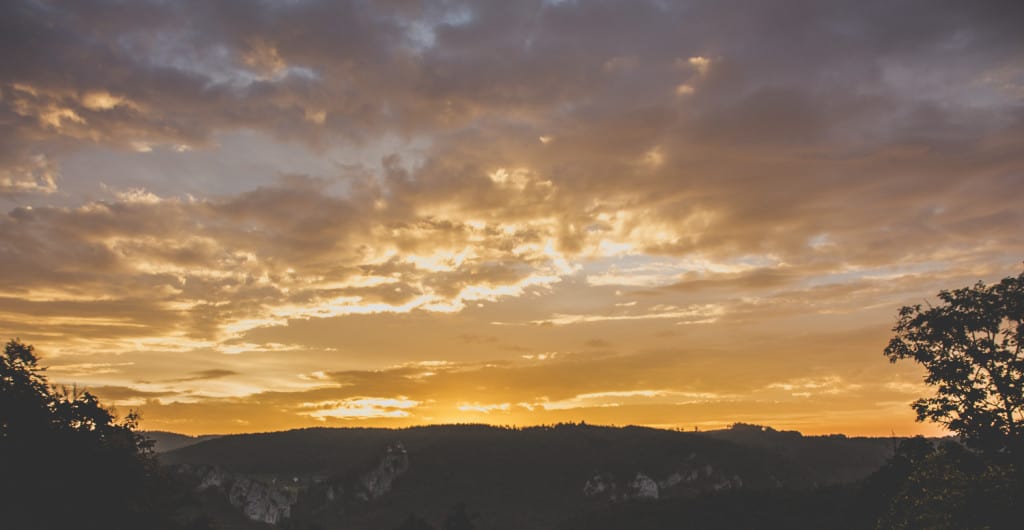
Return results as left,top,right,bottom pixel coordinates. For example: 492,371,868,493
0,177,585,353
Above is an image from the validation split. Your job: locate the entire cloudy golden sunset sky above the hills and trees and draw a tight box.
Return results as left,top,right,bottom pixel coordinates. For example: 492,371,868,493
0,0,1024,436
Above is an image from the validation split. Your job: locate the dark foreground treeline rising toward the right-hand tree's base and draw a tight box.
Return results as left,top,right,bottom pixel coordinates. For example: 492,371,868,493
559,438,1024,530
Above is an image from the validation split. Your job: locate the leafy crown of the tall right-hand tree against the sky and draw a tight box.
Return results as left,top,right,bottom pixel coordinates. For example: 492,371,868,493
885,273,1024,454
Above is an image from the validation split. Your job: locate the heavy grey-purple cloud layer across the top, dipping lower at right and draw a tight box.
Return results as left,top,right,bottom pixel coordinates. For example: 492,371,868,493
0,1,1024,254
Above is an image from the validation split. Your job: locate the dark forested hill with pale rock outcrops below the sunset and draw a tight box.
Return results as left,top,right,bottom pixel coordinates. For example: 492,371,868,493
162,425,895,529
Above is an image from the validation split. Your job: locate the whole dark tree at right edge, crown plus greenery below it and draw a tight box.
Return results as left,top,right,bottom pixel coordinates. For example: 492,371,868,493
874,273,1024,530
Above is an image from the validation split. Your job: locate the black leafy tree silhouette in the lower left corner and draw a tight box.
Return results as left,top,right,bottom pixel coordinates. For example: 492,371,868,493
0,340,205,530
